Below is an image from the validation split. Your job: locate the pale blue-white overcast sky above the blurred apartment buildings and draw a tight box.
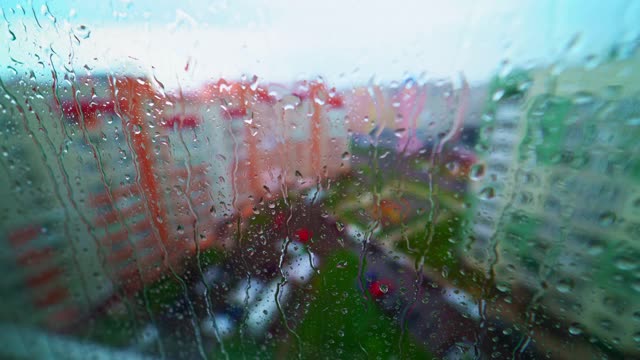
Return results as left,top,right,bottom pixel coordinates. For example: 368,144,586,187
0,0,640,87
